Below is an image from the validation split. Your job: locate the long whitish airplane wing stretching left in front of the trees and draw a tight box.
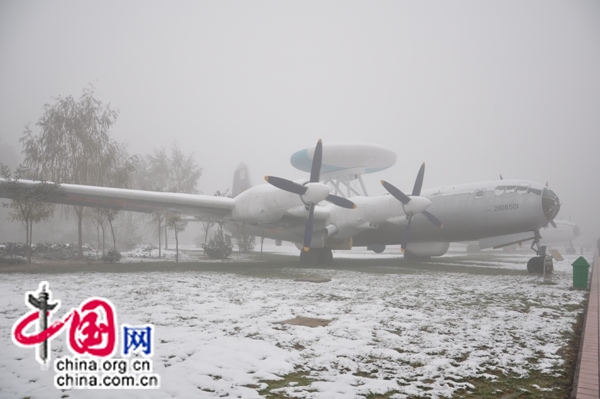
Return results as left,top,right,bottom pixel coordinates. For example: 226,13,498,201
0,179,234,220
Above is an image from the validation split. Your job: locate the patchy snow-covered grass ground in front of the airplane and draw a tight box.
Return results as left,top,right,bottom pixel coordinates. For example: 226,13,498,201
0,252,585,399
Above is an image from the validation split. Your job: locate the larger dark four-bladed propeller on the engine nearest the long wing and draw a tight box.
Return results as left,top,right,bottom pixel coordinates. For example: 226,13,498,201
265,139,356,252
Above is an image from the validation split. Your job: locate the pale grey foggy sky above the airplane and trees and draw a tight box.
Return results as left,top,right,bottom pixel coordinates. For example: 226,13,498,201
0,0,600,244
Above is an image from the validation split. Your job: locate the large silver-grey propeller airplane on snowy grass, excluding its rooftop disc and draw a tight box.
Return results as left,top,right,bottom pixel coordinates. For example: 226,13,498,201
0,140,560,272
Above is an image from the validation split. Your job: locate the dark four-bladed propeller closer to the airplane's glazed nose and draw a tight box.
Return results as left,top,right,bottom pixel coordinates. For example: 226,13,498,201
381,162,443,252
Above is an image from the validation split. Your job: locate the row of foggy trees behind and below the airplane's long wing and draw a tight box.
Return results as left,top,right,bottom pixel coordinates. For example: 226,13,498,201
0,86,241,262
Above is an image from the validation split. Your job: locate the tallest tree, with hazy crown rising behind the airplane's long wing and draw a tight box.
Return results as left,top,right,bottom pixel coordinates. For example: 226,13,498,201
20,86,132,257
